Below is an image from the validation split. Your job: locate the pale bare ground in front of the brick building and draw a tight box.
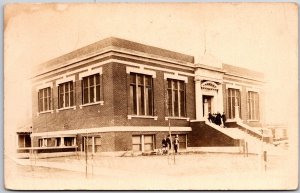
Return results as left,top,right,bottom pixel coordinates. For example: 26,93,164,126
5,153,296,190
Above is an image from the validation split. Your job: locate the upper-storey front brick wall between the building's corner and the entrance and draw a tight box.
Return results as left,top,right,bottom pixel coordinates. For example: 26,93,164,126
112,64,195,126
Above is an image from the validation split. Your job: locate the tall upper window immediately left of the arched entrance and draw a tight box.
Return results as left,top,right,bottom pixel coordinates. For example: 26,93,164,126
167,79,186,117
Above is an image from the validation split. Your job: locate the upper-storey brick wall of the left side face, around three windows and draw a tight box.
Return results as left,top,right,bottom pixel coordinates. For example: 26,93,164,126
32,64,114,132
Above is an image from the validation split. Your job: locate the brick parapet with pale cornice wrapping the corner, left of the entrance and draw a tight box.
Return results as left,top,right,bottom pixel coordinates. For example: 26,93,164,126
31,37,194,79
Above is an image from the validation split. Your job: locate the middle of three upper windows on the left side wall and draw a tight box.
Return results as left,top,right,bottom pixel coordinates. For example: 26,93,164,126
58,81,74,108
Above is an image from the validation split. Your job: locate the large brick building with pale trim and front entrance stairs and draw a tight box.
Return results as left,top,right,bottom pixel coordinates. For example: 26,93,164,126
31,38,270,153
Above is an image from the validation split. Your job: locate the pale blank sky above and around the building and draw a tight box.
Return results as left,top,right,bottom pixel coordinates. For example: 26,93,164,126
4,3,298,134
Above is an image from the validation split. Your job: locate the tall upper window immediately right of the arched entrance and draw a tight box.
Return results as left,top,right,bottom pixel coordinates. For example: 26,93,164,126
228,88,241,119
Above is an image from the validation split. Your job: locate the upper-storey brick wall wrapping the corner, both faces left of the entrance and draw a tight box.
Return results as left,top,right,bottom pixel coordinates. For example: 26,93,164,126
32,63,195,132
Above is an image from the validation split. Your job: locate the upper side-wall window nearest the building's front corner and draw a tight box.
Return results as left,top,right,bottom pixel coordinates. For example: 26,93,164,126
82,74,100,104
